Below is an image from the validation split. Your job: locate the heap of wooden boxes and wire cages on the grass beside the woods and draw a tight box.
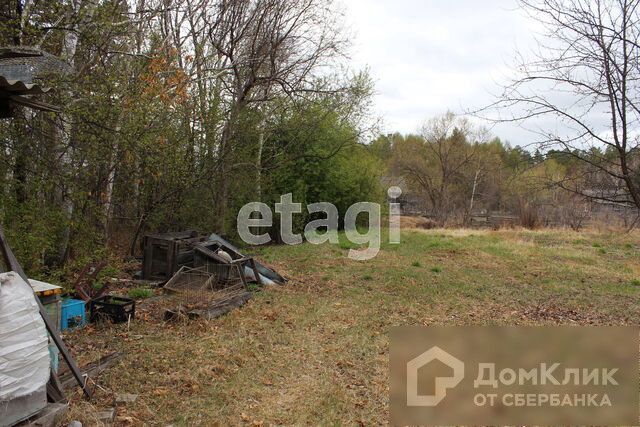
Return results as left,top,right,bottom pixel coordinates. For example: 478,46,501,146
142,230,286,320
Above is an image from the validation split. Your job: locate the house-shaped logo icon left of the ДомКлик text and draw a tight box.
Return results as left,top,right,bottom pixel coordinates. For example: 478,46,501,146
407,346,464,406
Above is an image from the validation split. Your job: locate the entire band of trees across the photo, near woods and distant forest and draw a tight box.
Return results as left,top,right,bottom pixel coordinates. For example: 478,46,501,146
0,0,640,278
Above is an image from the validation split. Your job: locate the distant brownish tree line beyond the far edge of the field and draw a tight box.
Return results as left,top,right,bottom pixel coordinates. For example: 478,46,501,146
371,112,640,229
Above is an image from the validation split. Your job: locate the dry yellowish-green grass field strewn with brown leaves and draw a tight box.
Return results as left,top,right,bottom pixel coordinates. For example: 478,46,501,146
62,230,640,425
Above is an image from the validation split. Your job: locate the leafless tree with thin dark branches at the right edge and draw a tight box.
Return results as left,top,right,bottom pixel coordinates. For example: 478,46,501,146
485,0,640,212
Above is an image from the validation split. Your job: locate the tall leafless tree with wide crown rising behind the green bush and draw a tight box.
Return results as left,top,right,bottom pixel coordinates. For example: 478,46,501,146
209,0,347,234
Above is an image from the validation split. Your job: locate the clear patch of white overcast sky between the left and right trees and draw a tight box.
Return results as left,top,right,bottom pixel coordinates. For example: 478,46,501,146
343,0,535,145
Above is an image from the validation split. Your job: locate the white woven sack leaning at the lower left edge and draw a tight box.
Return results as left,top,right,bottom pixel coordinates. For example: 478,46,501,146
0,271,51,401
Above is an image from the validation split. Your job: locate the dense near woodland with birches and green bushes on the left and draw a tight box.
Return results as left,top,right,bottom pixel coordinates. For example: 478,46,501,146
0,0,378,270
